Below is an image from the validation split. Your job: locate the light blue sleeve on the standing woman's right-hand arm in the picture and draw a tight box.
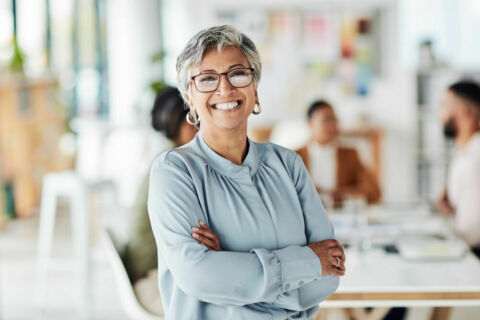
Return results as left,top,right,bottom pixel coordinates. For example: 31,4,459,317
268,155,339,311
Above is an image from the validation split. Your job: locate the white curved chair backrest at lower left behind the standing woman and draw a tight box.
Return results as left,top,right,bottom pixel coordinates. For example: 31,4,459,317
103,228,163,320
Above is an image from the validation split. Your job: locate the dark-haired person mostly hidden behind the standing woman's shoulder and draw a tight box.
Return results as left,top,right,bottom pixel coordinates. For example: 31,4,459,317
124,88,197,315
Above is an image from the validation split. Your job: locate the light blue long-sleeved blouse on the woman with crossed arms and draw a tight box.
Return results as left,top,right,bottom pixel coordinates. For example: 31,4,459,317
148,132,339,320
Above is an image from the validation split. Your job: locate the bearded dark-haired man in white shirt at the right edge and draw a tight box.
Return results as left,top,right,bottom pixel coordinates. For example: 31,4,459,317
437,80,480,257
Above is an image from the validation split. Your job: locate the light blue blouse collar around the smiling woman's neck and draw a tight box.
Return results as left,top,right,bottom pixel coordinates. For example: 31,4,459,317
195,132,258,178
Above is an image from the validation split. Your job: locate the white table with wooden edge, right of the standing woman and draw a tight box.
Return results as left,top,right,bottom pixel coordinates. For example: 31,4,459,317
320,211,480,318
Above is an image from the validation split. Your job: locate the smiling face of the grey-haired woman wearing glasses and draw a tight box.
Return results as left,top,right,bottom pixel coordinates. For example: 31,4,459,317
186,47,257,133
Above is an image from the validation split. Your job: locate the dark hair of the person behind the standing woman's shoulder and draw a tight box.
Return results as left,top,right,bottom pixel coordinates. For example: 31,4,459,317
151,87,188,140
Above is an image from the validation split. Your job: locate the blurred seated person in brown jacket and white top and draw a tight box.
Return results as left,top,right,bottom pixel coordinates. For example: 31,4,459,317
297,101,380,207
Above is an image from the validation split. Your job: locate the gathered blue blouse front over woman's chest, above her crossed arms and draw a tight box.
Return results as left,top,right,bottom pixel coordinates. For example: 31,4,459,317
193,166,306,252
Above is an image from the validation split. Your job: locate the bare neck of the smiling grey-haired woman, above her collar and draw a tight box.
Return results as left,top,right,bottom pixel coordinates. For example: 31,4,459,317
200,128,247,165
